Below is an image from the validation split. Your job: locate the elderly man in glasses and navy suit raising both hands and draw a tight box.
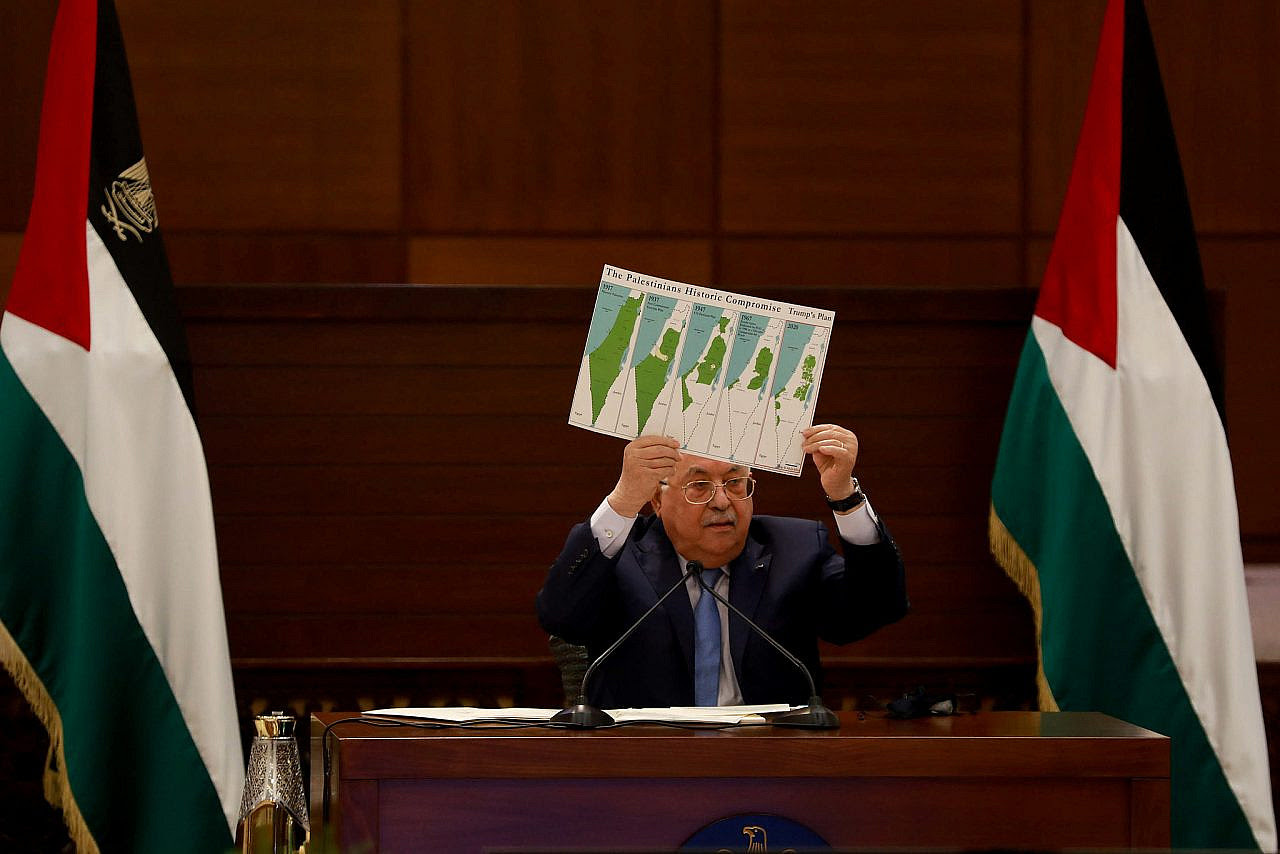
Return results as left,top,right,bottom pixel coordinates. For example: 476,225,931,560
538,424,908,708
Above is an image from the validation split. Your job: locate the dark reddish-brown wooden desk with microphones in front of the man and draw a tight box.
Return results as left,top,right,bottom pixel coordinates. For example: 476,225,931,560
311,712,1169,851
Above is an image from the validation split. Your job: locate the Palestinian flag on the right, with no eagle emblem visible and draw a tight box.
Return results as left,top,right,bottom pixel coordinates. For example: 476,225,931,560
991,0,1276,850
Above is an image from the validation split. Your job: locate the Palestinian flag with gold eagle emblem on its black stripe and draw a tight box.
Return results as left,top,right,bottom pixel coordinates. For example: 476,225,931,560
0,0,244,854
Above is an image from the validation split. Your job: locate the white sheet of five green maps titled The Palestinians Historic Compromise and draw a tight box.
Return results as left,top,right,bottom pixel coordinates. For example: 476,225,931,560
568,266,836,476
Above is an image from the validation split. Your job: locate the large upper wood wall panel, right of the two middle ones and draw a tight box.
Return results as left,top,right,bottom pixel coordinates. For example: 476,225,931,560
721,0,1021,234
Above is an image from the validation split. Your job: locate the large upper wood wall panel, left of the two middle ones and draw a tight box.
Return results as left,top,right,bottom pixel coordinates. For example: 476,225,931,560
406,0,714,233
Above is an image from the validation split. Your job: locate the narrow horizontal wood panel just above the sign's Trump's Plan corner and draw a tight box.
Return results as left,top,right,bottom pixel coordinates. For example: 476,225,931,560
719,237,1023,289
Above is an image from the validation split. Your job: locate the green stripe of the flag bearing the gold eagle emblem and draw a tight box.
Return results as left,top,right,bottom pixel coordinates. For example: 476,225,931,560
0,351,232,851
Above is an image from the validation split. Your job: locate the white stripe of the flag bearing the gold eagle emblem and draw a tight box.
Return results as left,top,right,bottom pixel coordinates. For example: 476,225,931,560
0,222,244,835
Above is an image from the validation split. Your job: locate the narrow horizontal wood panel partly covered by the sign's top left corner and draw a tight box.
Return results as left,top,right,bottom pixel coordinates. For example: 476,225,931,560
408,237,712,288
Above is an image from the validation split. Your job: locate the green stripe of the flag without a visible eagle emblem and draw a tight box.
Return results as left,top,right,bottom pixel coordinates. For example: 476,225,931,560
992,334,1256,849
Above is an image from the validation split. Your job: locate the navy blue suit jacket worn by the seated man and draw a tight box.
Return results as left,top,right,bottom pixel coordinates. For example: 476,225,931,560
538,516,908,708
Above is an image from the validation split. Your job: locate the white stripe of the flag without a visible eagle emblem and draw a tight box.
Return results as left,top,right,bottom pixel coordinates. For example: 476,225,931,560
1032,219,1276,850
